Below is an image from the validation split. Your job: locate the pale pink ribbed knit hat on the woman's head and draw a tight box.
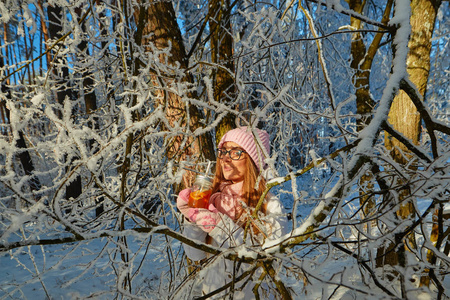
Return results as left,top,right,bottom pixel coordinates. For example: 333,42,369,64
218,126,270,170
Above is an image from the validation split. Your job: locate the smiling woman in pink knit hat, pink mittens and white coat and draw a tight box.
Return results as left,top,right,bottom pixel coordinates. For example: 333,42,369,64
177,127,285,299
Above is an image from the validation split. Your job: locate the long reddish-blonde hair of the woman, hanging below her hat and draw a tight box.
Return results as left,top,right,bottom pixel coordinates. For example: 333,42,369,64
212,153,266,218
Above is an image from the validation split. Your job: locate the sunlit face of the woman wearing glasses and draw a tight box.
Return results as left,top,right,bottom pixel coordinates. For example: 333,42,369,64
220,142,248,183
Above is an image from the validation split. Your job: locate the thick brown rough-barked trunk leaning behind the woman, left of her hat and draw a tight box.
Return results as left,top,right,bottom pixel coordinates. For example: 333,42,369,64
135,1,215,190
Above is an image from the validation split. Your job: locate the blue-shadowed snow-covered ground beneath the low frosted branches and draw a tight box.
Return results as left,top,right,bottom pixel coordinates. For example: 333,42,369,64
0,234,442,300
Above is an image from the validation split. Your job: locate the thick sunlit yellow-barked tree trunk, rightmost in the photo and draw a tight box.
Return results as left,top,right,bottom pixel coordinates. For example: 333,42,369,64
377,0,439,276
